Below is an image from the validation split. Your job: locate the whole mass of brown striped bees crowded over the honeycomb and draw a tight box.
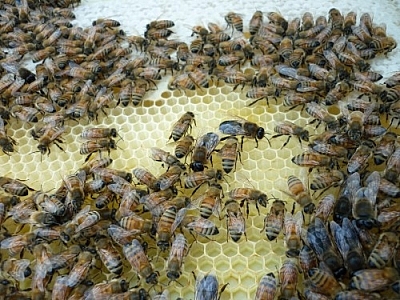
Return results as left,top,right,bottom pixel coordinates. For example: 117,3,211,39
0,0,400,299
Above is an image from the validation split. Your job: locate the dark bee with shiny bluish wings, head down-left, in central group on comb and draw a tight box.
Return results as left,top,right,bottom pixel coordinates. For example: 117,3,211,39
190,132,219,172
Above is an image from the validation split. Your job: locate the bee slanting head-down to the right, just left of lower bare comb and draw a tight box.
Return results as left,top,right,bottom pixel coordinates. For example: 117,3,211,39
122,239,158,284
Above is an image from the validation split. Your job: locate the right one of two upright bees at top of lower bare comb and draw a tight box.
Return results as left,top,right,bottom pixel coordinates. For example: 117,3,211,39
261,199,286,241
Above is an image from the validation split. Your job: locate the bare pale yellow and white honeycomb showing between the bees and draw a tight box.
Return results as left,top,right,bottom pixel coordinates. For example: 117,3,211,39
0,1,400,299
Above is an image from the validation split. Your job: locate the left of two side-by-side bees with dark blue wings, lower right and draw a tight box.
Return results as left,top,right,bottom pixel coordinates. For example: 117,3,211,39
306,217,346,277
